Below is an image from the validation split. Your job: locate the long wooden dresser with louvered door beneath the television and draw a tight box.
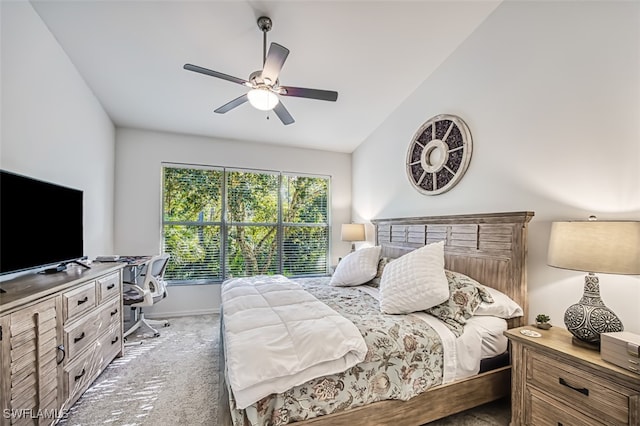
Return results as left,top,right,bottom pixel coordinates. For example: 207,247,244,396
0,263,123,426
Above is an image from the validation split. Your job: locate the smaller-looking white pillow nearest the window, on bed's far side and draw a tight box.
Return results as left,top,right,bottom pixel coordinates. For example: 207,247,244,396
329,246,382,287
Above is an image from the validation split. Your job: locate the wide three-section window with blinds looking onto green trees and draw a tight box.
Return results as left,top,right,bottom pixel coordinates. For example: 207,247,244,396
162,164,329,284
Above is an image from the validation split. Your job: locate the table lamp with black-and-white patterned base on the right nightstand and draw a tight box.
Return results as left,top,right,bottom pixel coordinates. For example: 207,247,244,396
547,216,640,350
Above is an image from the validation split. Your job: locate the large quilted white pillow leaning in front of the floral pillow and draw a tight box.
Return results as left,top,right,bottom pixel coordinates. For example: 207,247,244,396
380,241,449,314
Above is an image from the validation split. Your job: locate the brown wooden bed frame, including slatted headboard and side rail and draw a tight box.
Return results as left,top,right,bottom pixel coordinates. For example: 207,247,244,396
219,212,534,426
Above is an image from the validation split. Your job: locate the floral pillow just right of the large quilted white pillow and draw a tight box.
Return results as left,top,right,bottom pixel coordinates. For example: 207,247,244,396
426,270,493,337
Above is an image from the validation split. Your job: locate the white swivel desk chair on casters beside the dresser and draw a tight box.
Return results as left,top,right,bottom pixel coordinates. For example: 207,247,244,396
122,254,170,346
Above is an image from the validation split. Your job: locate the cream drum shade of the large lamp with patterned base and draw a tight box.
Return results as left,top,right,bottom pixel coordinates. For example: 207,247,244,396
547,221,640,275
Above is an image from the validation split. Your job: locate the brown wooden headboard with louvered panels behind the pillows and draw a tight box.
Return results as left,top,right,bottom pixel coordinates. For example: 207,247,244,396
371,212,534,328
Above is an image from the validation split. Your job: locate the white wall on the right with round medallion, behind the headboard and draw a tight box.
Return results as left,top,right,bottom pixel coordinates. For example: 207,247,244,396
353,1,640,333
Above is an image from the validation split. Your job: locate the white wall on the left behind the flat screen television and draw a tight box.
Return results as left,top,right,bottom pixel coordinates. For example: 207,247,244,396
0,1,115,270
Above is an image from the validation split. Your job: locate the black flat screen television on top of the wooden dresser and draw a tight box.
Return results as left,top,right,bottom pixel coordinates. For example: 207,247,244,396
0,170,84,275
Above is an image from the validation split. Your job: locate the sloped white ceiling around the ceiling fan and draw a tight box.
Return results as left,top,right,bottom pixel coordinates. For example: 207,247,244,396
31,0,500,152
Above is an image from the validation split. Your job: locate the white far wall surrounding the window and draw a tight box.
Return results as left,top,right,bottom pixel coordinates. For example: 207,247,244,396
115,129,351,317
